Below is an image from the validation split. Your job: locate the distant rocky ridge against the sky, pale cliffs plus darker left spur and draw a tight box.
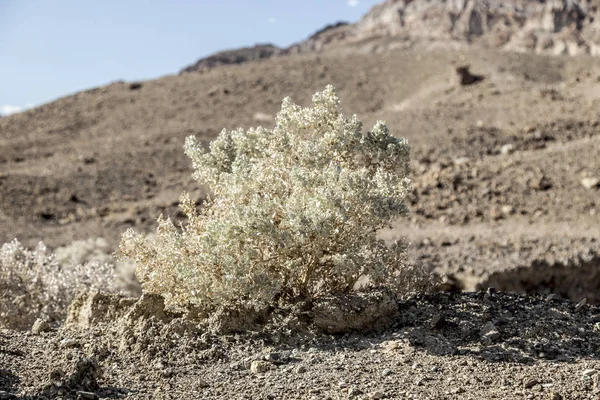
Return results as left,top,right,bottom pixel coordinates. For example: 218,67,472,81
182,0,600,73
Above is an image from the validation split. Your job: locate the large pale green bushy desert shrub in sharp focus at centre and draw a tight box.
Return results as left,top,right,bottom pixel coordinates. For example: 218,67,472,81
121,86,428,306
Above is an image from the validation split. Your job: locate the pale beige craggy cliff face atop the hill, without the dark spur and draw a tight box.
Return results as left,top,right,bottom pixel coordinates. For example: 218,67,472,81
304,0,600,55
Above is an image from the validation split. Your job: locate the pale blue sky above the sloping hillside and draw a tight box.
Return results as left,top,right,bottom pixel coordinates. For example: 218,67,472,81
0,0,377,115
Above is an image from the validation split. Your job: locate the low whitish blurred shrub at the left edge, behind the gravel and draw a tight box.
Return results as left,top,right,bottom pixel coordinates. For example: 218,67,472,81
0,239,114,329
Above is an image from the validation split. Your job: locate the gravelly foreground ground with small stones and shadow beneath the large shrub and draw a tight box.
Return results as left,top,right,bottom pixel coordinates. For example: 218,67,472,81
0,289,600,399
